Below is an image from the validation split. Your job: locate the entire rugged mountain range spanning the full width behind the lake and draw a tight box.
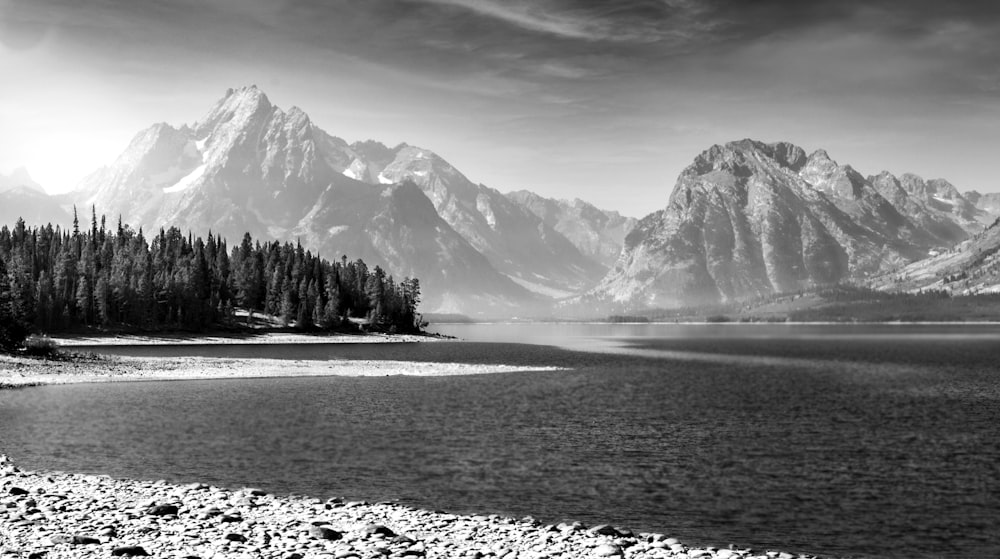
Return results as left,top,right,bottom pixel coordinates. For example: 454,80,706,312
0,93,1000,317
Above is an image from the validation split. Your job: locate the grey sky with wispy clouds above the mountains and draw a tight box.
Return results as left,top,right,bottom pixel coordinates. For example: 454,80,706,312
0,0,1000,217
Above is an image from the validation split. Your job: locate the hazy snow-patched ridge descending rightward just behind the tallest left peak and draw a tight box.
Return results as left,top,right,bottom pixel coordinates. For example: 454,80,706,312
336,141,606,297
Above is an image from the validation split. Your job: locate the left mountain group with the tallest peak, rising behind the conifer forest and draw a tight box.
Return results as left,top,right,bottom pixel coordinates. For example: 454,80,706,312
7,87,627,316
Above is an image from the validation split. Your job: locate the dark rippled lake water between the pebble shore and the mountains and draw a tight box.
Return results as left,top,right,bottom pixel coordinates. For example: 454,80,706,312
0,324,1000,559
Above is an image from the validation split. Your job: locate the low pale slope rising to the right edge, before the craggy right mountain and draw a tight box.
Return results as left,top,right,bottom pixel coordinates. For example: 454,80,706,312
867,219,1000,295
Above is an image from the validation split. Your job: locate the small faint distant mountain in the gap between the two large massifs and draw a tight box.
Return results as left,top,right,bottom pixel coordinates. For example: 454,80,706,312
507,190,638,268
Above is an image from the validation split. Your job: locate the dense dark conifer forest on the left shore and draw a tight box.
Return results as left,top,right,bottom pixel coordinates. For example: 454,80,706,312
0,208,420,349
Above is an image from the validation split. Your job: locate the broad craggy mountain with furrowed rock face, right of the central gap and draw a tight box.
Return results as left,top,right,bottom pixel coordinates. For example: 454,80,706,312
585,140,996,308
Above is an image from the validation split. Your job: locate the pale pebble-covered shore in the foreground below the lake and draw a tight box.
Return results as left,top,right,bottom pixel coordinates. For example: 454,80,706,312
0,456,828,559
